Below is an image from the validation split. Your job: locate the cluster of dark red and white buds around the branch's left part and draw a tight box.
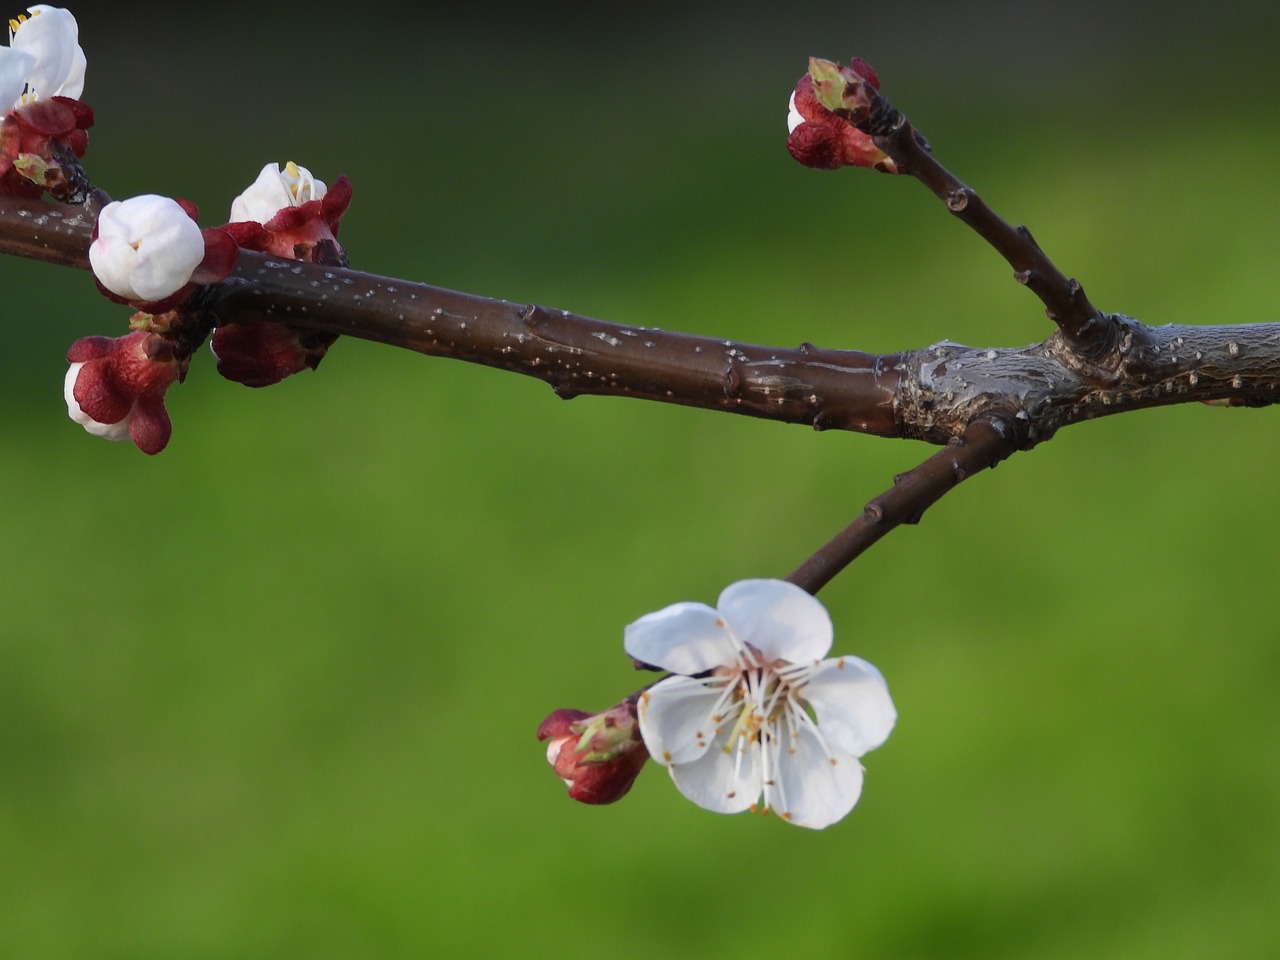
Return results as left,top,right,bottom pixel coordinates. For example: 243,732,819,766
65,156,351,453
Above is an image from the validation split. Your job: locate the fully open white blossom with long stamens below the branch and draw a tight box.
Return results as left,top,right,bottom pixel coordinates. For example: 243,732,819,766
625,580,897,828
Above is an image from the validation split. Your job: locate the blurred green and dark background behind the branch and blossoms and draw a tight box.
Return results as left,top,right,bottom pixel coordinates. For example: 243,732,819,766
0,3,1280,960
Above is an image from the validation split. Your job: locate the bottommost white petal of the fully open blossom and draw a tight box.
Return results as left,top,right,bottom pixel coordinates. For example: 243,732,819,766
764,724,863,829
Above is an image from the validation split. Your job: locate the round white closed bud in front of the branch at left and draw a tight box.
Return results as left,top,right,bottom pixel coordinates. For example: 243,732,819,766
88,193,205,301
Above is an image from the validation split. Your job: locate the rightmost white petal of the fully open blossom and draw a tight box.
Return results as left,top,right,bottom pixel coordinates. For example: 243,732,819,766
801,657,897,756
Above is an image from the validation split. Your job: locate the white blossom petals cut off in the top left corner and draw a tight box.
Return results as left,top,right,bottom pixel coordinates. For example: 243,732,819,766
0,4,87,109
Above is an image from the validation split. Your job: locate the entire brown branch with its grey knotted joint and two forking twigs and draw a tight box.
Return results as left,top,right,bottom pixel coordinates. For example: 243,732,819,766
10,150,1280,591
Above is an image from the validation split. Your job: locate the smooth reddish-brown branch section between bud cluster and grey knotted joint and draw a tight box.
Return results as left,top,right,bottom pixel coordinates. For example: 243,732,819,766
197,251,901,436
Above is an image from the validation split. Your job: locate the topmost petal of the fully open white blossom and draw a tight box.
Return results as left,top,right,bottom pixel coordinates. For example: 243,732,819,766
717,580,832,663
